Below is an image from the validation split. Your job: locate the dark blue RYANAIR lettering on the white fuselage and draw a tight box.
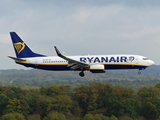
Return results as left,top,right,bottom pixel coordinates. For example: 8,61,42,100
80,56,134,63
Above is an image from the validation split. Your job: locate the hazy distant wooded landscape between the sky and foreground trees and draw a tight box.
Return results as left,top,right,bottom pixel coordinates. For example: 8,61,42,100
0,70,160,90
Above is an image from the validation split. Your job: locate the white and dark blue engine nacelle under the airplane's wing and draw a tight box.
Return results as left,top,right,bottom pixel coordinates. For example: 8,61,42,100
90,64,106,73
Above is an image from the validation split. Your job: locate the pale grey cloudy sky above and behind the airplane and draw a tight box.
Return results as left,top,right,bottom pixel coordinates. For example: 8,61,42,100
0,0,160,69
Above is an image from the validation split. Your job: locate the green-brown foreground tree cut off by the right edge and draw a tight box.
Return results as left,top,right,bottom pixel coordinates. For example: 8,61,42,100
137,87,160,120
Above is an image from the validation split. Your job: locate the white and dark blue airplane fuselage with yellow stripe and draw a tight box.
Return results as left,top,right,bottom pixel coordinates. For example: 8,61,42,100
16,54,154,70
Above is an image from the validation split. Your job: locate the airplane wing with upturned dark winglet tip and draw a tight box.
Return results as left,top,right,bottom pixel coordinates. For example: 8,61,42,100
54,46,90,70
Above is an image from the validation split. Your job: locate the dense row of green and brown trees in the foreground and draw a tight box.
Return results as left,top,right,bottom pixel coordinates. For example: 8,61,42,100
0,82,160,120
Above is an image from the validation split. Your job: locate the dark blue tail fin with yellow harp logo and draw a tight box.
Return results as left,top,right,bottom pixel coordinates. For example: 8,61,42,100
10,32,45,58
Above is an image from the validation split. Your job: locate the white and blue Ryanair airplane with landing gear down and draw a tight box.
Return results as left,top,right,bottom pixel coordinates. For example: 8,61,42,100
8,32,154,77
